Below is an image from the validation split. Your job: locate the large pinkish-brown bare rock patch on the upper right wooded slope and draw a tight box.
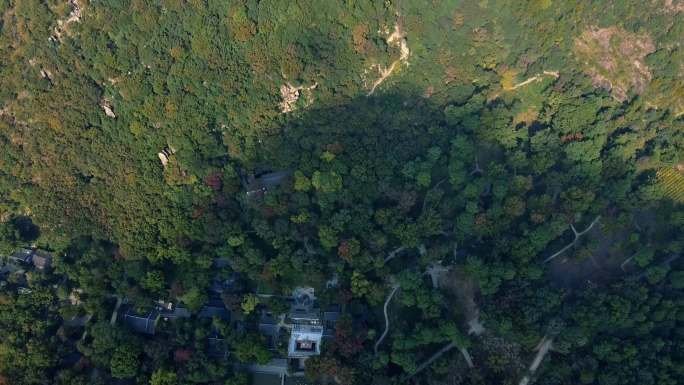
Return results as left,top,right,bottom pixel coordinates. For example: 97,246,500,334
574,27,655,101
